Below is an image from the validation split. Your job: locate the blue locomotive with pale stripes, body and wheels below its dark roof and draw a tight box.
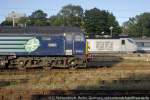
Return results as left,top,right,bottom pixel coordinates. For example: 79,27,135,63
0,33,86,69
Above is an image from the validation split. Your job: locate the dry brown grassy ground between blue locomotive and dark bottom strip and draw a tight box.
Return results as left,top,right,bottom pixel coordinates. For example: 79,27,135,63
0,62,150,99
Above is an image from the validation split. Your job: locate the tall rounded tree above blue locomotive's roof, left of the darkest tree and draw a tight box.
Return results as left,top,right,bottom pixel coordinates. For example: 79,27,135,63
50,5,83,27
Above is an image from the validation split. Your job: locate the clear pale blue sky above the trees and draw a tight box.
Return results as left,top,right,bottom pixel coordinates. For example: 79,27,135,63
0,0,150,25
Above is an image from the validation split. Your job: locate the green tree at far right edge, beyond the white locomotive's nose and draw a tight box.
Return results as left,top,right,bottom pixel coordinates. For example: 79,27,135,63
123,13,150,37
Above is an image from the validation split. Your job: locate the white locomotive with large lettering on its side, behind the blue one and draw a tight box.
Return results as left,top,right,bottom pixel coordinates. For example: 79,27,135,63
86,38,137,53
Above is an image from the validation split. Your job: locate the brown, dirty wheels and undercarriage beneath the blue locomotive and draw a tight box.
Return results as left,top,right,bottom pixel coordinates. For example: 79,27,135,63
1,56,85,70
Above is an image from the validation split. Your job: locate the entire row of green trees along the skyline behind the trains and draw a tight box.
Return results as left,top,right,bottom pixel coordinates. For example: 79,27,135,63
1,5,150,37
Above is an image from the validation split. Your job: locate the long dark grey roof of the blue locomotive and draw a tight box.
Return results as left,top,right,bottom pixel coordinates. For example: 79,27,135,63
0,26,83,34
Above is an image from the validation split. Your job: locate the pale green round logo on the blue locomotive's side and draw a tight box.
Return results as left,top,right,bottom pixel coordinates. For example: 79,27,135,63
25,38,40,52
